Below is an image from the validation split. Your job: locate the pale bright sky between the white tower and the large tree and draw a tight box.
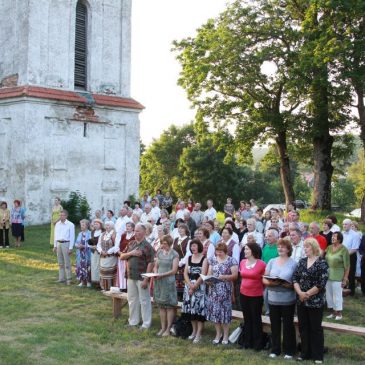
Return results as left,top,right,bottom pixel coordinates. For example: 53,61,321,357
132,0,229,145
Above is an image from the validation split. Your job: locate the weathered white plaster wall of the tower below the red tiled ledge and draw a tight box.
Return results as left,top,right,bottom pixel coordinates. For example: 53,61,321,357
0,96,139,224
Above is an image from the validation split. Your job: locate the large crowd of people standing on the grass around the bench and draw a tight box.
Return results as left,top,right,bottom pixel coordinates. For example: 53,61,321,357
10,190,365,363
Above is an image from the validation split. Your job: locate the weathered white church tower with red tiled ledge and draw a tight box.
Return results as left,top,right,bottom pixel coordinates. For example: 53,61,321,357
0,0,143,224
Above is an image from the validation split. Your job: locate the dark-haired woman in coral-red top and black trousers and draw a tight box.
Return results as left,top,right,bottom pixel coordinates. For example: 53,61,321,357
239,243,266,351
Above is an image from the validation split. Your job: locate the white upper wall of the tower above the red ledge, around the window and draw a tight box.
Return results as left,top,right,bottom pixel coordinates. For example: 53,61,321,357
0,0,131,97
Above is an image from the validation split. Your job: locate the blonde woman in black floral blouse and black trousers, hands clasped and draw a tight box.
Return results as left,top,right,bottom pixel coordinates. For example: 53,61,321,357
293,238,328,364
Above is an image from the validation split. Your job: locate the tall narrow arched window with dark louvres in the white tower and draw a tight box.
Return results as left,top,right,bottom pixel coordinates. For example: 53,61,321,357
75,1,87,90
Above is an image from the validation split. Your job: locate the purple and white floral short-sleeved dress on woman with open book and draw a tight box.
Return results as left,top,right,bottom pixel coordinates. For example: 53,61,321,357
206,256,238,324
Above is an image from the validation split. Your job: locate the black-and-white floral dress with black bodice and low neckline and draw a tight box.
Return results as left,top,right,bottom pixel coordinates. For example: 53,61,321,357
181,256,206,322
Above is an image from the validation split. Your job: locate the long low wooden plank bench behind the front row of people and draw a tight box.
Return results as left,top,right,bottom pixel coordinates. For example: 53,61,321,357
103,291,365,337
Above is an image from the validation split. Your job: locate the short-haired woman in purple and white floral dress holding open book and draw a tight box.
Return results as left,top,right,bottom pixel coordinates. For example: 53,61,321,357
206,242,238,345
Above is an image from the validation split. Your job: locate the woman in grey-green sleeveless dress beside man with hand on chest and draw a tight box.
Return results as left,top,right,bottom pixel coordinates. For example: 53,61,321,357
153,236,179,337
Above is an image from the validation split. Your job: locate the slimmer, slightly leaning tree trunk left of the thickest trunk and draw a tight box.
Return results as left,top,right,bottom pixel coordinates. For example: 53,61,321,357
275,132,295,208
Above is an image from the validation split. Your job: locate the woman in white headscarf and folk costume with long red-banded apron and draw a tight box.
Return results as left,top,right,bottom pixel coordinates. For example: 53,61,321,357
97,221,117,291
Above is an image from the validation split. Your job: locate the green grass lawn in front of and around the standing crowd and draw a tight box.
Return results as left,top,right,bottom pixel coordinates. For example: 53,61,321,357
0,226,365,365
